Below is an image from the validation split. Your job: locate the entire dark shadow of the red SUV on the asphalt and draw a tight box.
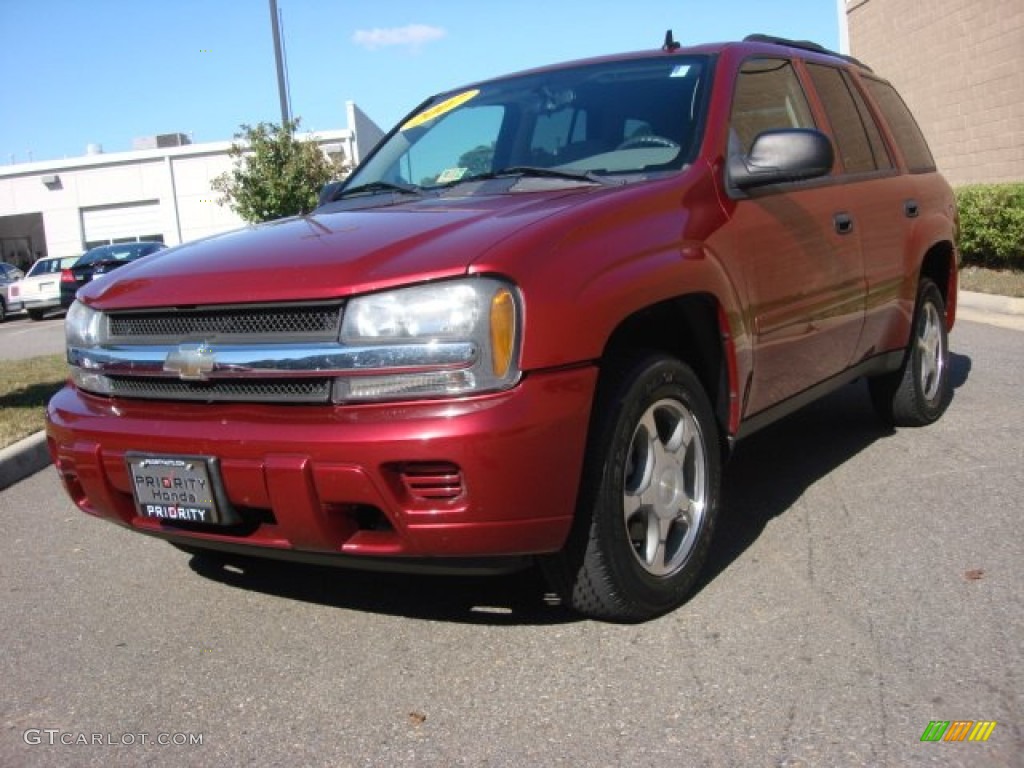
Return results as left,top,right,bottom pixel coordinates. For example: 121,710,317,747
189,354,971,626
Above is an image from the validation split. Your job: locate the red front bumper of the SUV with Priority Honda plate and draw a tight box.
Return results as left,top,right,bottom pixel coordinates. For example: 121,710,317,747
47,368,597,570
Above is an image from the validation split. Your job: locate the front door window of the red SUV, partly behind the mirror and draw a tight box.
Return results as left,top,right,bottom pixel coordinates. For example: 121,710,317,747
729,58,815,155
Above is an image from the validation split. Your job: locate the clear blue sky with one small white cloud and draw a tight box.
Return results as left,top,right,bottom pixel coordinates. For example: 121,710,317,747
0,0,839,165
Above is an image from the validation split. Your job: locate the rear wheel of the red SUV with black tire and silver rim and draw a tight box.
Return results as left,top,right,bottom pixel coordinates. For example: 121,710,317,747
867,278,952,427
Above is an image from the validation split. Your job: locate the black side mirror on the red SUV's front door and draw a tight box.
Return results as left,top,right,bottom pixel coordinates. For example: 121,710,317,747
728,128,834,189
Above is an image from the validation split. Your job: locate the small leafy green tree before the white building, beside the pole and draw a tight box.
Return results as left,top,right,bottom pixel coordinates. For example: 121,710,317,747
211,118,347,223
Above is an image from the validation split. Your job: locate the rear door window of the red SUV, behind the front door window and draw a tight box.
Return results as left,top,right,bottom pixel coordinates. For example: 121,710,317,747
807,65,892,173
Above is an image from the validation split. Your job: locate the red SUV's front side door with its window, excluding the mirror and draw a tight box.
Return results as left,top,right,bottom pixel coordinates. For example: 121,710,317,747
728,57,864,416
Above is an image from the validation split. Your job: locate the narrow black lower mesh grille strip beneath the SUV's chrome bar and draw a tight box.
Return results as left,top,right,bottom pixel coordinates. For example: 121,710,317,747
103,376,331,403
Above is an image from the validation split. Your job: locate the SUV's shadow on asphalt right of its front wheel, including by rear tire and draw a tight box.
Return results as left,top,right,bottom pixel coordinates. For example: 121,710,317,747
695,353,971,592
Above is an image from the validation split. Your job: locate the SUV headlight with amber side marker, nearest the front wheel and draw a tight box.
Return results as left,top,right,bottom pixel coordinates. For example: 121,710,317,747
335,278,520,401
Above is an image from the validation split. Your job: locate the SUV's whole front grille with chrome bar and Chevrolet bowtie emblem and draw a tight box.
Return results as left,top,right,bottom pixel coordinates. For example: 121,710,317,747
68,301,479,404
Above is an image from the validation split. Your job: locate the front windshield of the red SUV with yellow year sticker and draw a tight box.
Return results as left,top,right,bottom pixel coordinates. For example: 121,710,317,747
340,54,709,195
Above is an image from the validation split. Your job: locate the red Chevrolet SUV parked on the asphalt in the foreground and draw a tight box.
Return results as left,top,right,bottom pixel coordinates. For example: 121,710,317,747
47,35,958,621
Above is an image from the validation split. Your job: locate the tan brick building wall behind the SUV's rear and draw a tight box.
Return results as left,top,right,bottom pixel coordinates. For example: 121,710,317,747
846,0,1024,185
